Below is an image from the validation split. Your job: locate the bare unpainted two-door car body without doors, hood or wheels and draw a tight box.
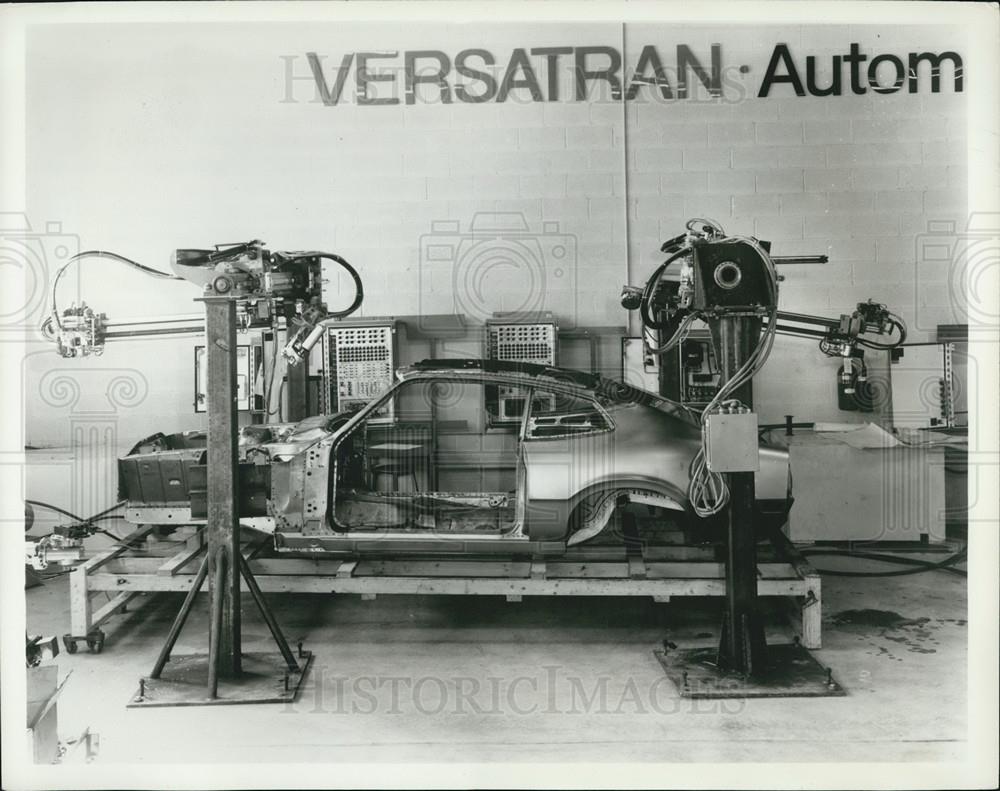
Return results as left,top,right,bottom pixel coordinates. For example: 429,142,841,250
120,360,790,555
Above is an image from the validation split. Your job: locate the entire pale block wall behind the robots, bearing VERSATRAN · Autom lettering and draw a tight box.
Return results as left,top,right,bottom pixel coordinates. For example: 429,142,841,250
19,23,966,444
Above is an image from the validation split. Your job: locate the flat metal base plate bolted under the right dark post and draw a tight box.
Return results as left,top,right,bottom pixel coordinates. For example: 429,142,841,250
653,643,847,698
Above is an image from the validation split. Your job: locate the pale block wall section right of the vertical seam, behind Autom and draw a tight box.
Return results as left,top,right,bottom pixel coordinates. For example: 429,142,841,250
625,26,968,422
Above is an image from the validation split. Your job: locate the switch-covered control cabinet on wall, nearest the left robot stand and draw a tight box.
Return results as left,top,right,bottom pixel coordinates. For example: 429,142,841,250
323,319,396,423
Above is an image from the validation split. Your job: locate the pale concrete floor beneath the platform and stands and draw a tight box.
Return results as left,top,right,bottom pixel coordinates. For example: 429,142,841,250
26,555,967,764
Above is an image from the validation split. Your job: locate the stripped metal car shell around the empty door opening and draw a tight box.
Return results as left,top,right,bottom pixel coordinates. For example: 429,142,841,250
123,360,790,555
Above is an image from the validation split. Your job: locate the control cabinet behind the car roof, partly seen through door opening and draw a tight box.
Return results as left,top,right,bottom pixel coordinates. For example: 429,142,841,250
485,313,559,427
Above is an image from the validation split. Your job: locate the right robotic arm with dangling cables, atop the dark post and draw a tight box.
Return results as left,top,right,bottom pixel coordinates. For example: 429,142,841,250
621,218,906,517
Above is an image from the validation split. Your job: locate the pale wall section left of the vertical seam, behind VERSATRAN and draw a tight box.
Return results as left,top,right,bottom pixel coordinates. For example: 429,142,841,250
27,25,626,444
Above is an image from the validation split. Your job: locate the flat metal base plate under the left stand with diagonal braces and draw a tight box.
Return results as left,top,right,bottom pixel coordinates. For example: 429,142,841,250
128,651,313,708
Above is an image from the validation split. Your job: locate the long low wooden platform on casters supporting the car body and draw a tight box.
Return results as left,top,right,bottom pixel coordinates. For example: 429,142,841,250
66,526,822,650
